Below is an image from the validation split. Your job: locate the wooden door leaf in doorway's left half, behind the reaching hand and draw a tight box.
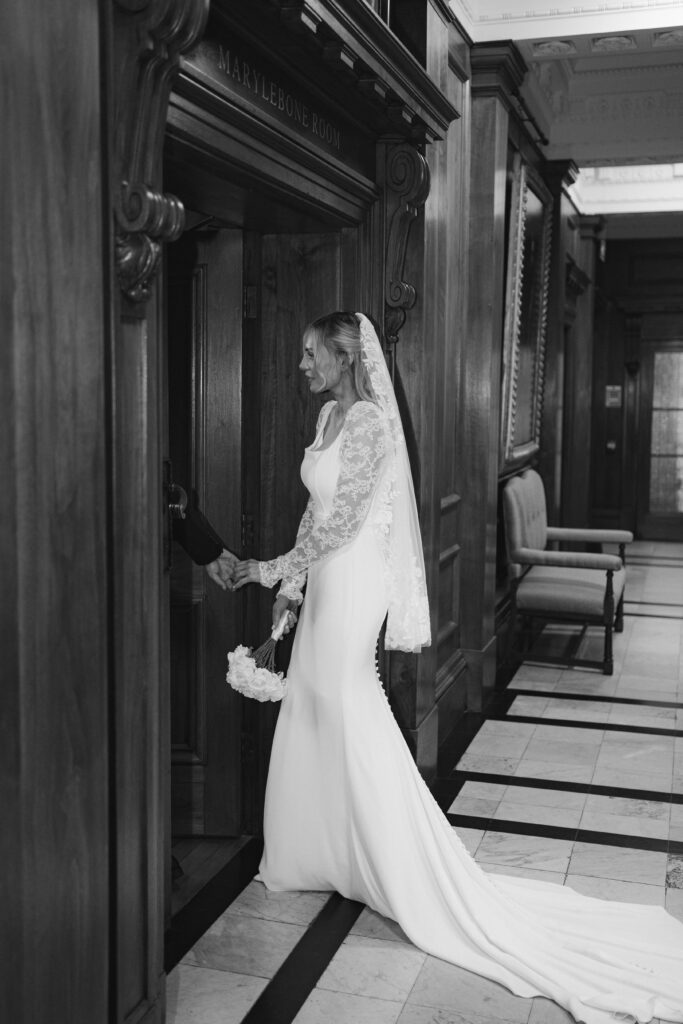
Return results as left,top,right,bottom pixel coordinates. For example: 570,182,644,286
167,230,243,836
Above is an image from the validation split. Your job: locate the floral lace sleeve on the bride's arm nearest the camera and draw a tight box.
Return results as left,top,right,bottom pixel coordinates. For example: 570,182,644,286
259,401,387,587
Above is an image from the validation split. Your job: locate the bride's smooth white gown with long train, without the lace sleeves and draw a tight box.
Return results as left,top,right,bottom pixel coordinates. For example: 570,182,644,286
259,405,683,1024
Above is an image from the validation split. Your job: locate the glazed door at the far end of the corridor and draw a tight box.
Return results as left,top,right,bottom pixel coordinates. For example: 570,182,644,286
637,339,683,541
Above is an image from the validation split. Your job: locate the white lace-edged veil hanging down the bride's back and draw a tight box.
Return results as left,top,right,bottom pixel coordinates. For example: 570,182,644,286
355,313,431,651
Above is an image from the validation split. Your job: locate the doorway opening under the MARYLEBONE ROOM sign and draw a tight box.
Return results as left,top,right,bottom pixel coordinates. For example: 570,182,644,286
165,151,359,923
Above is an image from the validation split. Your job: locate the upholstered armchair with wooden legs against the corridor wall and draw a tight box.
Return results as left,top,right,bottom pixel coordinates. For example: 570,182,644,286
503,469,633,676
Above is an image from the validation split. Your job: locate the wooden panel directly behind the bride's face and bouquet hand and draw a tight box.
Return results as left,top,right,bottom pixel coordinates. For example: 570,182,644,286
237,228,358,833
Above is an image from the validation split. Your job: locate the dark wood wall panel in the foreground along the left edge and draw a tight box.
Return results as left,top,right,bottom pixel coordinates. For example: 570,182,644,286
0,0,111,1024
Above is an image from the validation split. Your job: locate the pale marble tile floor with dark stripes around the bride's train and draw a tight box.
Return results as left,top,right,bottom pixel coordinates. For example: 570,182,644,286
167,542,683,1024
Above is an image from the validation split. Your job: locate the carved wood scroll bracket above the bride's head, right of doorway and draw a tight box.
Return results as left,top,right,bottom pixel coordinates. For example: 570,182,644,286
384,143,430,345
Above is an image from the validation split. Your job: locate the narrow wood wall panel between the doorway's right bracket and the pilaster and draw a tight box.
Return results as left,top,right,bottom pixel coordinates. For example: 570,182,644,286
425,12,471,757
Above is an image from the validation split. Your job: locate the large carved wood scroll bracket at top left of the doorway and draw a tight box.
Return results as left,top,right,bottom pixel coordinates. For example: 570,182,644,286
114,0,209,311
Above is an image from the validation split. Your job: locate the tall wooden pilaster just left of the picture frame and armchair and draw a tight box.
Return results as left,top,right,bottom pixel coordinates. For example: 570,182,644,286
457,48,519,711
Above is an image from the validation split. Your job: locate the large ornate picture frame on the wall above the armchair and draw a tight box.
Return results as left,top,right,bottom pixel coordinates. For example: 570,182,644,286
501,153,553,472
